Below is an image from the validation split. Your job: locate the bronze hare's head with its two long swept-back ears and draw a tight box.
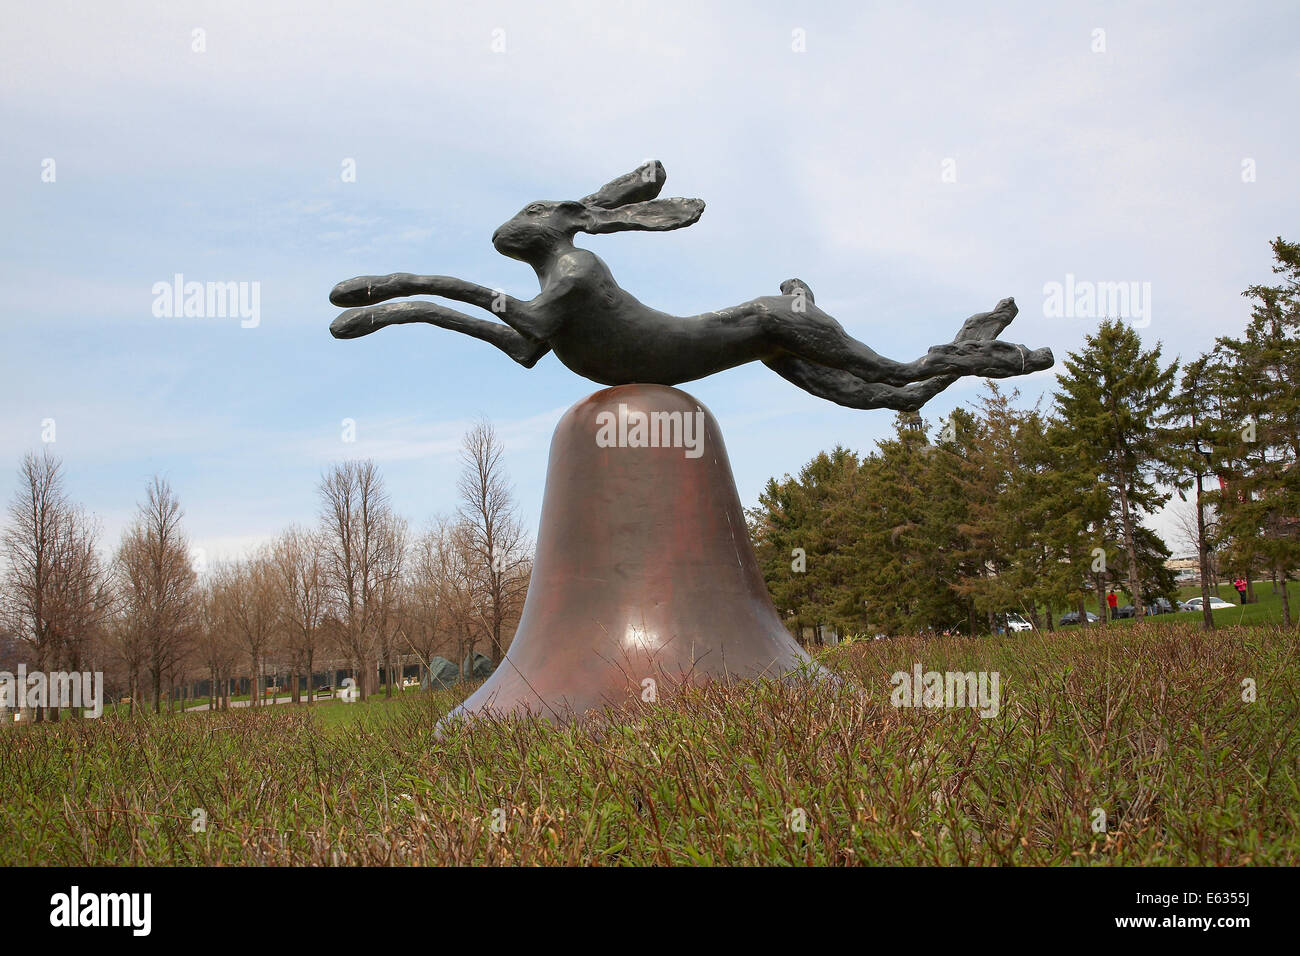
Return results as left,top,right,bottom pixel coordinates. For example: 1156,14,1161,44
491,160,705,264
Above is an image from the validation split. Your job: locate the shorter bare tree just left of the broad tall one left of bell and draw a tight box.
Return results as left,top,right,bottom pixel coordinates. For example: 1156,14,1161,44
272,525,326,705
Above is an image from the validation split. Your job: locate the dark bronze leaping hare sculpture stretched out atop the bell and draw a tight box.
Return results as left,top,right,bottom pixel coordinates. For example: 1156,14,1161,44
329,161,1053,411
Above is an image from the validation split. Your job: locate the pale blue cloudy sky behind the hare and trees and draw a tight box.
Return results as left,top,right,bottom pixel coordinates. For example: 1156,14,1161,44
0,0,1300,557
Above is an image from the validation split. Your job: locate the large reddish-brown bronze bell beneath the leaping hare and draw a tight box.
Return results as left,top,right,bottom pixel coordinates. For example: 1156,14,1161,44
446,385,828,722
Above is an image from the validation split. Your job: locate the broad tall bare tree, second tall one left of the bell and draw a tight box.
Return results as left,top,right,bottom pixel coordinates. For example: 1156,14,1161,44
317,460,403,700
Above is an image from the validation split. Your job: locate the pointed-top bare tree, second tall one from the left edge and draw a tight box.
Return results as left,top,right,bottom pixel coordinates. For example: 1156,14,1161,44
116,475,198,713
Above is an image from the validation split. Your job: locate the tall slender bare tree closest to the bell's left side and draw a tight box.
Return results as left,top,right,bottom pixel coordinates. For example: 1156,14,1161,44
456,421,528,665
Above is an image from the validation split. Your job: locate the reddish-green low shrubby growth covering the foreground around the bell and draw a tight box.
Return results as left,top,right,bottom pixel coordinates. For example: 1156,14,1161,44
0,622,1300,865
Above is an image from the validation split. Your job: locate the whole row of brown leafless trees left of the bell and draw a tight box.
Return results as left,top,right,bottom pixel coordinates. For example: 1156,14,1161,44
0,423,530,721
